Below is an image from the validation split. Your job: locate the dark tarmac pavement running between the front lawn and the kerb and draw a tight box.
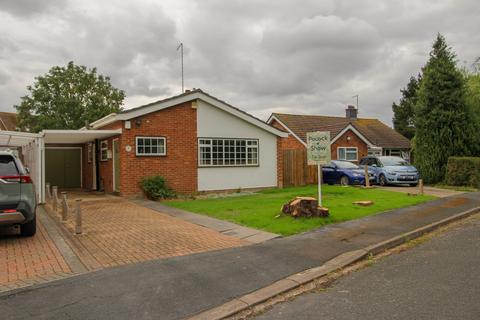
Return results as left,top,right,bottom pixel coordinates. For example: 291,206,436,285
0,193,480,319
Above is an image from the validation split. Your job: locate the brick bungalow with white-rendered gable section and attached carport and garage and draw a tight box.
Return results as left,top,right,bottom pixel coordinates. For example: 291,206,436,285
44,89,287,196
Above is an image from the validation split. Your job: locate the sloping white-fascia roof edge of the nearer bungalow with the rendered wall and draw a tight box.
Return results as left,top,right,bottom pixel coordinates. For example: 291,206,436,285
90,89,287,137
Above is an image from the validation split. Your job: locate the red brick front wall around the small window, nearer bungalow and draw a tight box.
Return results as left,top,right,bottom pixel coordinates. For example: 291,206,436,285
100,102,198,196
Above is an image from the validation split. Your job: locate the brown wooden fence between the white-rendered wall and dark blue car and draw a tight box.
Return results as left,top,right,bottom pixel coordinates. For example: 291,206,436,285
283,149,318,187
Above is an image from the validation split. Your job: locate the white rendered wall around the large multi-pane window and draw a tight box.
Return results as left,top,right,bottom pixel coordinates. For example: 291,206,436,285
197,100,277,191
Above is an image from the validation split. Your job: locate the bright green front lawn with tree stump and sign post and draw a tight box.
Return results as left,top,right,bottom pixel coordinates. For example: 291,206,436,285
164,185,434,236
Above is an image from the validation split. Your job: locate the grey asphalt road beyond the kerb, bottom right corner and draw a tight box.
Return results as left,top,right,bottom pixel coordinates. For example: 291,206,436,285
255,215,480,320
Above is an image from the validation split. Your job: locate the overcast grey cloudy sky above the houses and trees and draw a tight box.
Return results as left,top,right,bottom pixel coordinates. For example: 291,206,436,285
0,0,480,124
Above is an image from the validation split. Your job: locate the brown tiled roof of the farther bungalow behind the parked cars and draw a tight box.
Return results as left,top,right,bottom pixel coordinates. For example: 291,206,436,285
269,113,410,149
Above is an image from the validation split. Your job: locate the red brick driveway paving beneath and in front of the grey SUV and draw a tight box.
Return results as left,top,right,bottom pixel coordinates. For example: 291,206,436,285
0,220,71,292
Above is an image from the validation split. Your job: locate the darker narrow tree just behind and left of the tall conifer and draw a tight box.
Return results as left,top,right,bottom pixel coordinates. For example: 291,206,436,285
392,74,422,140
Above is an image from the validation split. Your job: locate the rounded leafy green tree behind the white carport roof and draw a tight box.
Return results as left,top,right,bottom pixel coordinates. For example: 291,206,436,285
14,62,125,132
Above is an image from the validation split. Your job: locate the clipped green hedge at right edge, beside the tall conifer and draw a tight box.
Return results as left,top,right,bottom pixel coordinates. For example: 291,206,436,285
445,157,480,188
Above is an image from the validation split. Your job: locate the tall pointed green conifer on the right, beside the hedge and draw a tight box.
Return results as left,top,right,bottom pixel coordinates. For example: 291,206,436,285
415,34,473,183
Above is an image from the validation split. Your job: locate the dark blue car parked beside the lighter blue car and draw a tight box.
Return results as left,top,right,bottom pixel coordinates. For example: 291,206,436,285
322,160,375,186
